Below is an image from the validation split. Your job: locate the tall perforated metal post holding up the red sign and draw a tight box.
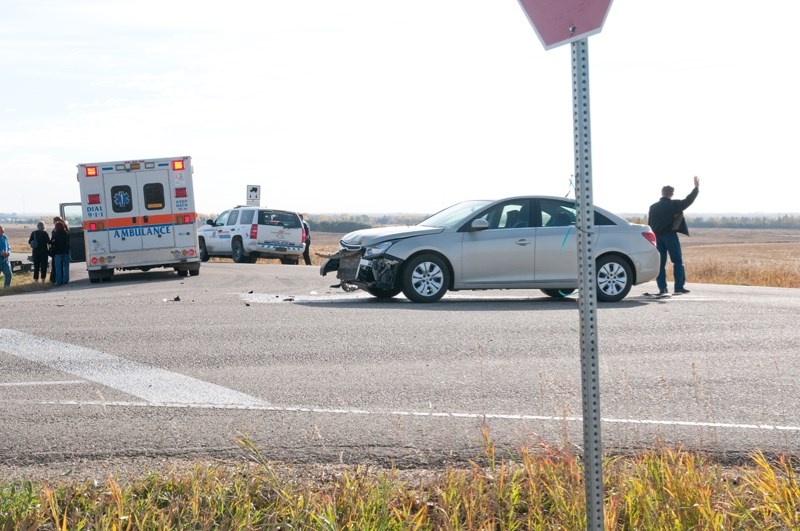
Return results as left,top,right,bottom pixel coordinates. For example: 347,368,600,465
570,39,604,530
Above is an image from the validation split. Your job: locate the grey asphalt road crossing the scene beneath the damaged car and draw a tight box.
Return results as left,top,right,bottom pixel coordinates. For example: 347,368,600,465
0,263,800,474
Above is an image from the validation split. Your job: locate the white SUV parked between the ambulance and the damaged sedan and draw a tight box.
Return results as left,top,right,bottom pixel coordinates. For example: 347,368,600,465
197,206,306,264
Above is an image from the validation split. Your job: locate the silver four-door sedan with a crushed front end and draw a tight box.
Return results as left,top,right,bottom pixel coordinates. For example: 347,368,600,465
320,196,659,302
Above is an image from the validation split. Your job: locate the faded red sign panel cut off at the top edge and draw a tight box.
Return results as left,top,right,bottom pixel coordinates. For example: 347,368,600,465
519,0,611,50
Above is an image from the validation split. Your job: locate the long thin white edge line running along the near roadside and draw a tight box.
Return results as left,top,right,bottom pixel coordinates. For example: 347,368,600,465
28,400,800,432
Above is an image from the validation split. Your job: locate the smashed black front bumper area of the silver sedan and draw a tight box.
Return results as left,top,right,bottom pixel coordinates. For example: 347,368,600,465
319,249,403,291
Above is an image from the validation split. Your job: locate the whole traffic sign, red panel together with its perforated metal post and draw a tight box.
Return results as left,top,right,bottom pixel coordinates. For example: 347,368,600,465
519,0,611,530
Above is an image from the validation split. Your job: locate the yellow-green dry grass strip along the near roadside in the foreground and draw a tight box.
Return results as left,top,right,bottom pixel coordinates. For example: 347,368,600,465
0,436,800,531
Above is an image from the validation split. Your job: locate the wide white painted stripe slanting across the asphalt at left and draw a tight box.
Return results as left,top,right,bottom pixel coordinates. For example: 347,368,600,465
0,329,267,406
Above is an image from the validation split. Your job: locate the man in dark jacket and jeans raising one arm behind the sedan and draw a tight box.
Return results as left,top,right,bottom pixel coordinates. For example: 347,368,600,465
647,177,700,295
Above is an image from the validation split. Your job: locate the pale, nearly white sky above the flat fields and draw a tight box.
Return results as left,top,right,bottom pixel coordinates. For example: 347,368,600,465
0,0,800,214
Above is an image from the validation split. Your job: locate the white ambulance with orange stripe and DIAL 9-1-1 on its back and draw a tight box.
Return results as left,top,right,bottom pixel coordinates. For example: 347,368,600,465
61,157,200,283
